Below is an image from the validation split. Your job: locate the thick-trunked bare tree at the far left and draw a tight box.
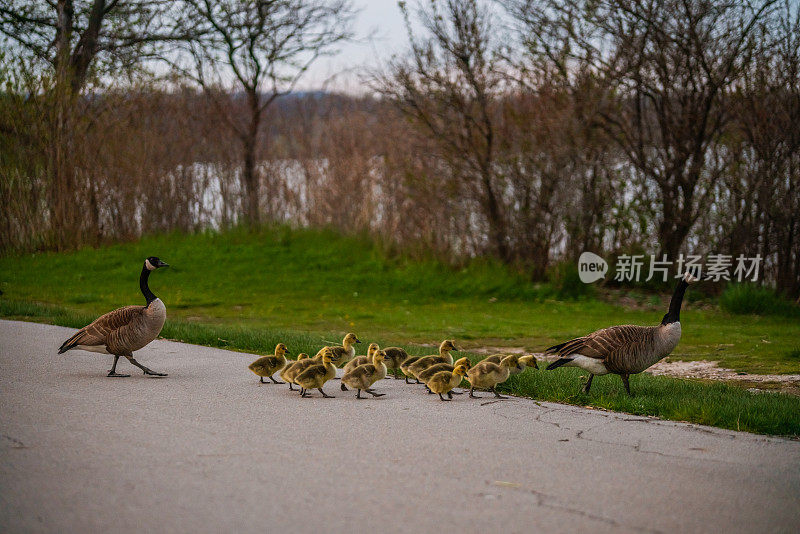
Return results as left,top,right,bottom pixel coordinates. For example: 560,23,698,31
0,0,190,247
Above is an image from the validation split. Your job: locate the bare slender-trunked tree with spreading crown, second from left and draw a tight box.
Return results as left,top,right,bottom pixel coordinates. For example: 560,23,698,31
183,0,354,225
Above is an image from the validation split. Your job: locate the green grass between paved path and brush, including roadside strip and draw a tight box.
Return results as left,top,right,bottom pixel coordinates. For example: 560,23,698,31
0,228,800,435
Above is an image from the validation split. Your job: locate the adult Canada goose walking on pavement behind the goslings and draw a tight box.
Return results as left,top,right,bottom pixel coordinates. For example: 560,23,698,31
58,256,168,377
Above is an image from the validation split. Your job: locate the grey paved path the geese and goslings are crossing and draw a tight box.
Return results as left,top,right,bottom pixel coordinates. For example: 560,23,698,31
0,321,800,534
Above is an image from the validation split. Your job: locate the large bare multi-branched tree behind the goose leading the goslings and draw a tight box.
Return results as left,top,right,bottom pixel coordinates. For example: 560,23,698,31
512,0,776,258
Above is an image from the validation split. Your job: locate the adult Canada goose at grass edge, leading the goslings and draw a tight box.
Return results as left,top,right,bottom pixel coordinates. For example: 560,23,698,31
545,272,697,395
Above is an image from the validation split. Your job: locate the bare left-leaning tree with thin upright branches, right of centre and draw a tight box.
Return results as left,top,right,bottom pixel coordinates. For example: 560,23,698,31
373,0,511,261
